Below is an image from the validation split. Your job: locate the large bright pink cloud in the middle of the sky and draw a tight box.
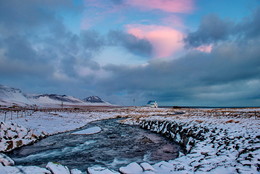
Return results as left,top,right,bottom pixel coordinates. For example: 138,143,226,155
127,25,184,58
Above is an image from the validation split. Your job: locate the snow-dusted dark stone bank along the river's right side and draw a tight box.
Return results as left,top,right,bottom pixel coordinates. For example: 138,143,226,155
140,118,260,173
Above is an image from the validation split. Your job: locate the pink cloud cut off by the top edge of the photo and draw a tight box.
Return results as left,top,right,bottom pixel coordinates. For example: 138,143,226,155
127,0,194,13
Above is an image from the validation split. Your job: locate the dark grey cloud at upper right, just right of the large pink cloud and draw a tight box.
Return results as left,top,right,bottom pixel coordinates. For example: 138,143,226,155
184,8,260,47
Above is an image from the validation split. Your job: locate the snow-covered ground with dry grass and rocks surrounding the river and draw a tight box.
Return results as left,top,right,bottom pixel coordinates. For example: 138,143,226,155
0,108,260,174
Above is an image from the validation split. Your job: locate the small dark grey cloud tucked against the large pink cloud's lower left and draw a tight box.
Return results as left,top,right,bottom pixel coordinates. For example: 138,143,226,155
108,31,152,57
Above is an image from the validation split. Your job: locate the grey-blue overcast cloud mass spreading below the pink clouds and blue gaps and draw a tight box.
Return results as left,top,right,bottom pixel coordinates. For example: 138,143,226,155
0,0,260,106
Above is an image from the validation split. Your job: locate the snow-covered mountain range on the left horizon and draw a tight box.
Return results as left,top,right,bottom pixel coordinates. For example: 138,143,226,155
0,85,111,107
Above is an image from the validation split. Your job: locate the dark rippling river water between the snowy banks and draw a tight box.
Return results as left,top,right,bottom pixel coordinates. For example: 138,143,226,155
8,119,180,171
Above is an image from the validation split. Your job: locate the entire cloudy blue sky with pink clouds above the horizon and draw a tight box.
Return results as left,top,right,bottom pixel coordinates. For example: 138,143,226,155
0,0,260,107
